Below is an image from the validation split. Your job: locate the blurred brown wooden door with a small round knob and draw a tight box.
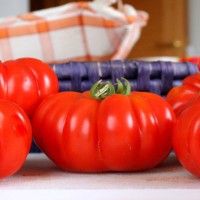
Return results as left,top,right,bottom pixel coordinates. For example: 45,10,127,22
127,0,188,58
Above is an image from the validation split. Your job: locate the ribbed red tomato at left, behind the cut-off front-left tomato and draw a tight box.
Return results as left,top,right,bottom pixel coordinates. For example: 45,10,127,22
0,58,59,117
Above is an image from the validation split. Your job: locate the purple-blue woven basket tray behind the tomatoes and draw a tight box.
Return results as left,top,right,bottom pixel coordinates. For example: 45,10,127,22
30,60,198,152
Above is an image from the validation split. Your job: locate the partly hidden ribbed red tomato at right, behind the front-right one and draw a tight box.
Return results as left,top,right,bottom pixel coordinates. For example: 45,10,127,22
166,73,200,115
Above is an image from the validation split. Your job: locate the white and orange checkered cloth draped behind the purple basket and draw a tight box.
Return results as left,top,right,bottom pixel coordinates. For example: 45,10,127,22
0,0,148,64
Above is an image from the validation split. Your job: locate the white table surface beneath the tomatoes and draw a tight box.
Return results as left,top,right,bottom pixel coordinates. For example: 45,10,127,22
0,153,200,200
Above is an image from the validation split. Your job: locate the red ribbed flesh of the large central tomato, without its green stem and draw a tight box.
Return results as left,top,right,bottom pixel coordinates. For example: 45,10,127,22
32,92,176,172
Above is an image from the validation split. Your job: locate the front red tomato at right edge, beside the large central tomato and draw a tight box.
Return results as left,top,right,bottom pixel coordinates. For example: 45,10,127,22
173,98,200,177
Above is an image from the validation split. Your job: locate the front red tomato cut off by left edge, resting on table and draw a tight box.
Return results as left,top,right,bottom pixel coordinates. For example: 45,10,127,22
0,100,32,178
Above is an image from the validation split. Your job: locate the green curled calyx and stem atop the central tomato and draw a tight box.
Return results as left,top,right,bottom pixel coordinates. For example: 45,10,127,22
90,78,131,101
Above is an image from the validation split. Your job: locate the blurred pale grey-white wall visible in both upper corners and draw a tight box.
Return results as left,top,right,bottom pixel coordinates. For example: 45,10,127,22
0,0,200,56
